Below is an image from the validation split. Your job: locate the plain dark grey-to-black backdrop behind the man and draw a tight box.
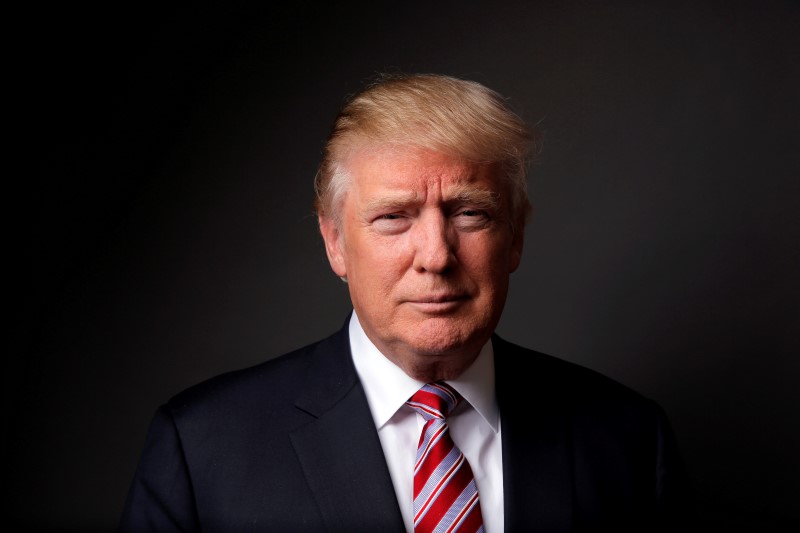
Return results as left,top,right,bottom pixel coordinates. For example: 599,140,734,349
7,0,800,531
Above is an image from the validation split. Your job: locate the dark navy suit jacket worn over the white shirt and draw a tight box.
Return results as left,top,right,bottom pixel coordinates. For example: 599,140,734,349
120,318,688,532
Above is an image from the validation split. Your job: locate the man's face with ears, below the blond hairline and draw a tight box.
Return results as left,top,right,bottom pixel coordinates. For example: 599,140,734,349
319,143,522,382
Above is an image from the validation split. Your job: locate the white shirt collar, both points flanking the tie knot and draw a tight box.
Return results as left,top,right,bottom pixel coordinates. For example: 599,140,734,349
349,311,499,432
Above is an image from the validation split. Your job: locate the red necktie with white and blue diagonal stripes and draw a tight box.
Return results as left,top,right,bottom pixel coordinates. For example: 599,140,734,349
406,381,484,533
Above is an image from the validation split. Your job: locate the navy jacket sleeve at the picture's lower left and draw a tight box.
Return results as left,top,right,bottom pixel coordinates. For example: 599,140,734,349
118,406,200,533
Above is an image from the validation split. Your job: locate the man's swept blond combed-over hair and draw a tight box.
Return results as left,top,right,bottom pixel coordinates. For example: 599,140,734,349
314,74,533,230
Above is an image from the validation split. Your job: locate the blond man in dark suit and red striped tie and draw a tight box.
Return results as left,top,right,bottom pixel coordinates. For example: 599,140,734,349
121,75,688,533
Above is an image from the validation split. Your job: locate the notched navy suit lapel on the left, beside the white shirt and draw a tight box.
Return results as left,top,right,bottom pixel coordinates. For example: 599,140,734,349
291,327,403,531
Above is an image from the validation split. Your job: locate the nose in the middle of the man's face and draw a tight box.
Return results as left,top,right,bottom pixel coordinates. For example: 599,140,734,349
411,213,457,274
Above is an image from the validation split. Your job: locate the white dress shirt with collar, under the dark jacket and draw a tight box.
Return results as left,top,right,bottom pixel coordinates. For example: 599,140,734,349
349,311,503,533
